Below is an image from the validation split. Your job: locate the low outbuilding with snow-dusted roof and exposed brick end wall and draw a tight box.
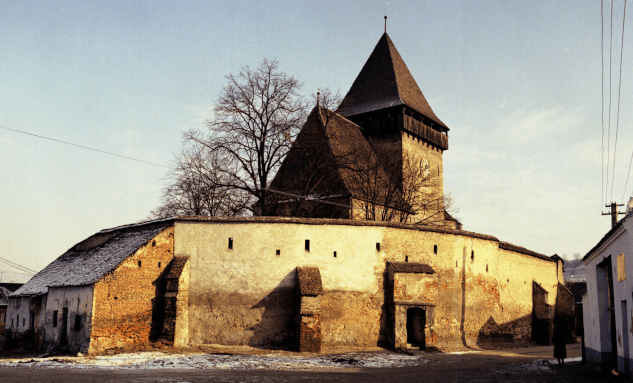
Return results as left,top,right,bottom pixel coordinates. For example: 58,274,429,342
5,221,178,352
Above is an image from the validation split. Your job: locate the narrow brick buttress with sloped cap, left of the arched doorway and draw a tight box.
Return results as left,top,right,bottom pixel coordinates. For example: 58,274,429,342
297,267,323,353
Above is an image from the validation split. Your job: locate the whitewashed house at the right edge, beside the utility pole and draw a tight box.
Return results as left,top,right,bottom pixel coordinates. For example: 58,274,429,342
582,213,633,374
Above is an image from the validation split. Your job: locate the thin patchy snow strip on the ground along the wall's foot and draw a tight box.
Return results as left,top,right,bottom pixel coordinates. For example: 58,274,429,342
0,352,428,370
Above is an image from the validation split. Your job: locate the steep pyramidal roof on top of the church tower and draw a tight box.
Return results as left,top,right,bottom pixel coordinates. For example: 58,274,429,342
337,33,448,129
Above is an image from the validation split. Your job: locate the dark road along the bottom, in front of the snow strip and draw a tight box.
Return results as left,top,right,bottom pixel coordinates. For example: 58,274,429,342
0,346,624,383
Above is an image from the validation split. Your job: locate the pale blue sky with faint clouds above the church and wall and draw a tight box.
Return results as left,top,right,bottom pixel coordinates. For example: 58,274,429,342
0,0,633,270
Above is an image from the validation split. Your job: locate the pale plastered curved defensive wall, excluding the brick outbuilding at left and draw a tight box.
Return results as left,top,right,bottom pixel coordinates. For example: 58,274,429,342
174,217,562,347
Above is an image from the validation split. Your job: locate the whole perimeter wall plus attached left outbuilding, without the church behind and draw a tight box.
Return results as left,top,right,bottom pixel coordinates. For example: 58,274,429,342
7,217,569,353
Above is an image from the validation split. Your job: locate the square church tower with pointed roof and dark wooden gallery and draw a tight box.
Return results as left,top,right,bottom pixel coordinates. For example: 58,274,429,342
337,33,449,216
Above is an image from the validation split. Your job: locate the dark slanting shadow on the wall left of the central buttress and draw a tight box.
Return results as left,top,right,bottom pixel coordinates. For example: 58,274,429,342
246,269,297,350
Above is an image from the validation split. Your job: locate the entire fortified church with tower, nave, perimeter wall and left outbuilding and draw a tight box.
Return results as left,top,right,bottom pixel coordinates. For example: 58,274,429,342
5,33,573,353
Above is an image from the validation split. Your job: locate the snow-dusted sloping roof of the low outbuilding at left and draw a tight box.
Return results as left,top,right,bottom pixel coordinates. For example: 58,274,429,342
11,222,171,297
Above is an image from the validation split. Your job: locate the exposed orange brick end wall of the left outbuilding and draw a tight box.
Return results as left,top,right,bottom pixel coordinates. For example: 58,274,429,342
90,227,174,353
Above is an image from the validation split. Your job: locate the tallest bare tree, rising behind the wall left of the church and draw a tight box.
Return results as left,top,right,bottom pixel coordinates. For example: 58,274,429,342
180,59,306,215
